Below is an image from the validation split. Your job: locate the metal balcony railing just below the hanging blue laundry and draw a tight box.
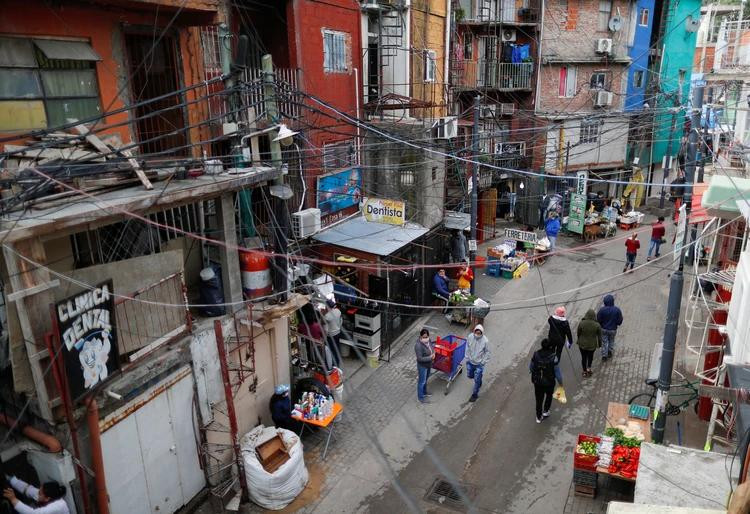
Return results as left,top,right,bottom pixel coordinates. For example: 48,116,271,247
453,59,534,91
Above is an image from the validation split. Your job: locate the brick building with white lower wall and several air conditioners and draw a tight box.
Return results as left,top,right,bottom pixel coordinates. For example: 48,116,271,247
535,0,635,196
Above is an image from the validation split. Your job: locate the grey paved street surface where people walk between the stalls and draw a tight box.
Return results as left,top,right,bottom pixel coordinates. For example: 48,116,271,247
232,221,704,513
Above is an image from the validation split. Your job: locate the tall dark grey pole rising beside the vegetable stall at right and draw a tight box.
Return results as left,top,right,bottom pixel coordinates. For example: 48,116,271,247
653,86,703,443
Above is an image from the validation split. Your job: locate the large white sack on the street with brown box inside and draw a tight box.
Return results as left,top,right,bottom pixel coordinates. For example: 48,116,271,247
240,425,308,510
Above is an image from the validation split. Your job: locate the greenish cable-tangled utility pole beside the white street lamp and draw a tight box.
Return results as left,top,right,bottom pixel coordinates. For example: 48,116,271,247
261,54,292,303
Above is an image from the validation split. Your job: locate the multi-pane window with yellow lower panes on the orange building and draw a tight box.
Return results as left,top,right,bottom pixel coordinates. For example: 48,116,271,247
0,37,102,131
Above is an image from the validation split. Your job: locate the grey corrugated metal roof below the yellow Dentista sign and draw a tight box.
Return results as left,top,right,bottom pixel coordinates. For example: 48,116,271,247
313,216,428,256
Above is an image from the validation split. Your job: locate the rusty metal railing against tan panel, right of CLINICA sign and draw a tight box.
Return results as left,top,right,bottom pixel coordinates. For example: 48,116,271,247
115,272,190,360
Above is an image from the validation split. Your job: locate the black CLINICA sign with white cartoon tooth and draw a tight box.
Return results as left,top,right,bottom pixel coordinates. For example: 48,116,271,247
55,280,120,401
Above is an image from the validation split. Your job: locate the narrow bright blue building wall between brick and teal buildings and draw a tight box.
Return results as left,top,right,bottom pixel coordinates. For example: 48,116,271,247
625,0,655,111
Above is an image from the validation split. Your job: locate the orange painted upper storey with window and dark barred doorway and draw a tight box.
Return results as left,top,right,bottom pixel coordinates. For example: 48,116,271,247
0,0,225,156
